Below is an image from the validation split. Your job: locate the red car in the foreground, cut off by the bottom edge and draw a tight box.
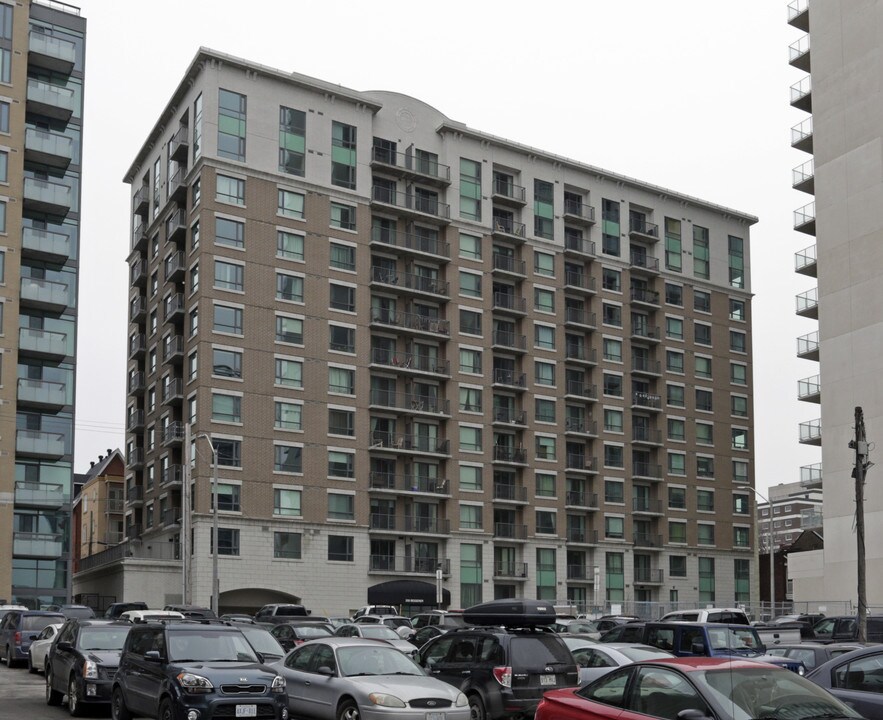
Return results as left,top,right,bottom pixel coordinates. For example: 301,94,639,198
536,657,861,720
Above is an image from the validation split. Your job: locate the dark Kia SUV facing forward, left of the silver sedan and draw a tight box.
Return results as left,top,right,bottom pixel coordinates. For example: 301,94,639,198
111,620,288,720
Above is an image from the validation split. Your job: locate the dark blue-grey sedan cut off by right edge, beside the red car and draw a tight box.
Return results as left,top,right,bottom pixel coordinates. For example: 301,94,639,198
806,645,883,718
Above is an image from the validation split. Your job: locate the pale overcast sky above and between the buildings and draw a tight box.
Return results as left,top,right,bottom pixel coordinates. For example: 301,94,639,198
71,0,819,493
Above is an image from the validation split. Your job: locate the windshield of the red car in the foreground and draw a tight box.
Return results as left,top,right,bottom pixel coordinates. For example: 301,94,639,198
690,666,861,720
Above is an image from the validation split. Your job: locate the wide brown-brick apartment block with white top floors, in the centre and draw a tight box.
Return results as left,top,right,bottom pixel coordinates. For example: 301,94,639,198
77,49,756,613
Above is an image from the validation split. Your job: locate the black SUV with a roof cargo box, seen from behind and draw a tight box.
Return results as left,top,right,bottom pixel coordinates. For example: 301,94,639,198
417,601,579,720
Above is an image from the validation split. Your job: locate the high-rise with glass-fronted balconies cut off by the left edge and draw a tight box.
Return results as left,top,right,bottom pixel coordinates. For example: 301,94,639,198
0,0,86,607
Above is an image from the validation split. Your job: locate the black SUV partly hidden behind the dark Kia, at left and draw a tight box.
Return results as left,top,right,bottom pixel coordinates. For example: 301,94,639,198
46,618,132,717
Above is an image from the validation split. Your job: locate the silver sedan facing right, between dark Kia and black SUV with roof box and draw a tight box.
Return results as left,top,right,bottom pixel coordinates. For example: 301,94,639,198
272,637,469,720
